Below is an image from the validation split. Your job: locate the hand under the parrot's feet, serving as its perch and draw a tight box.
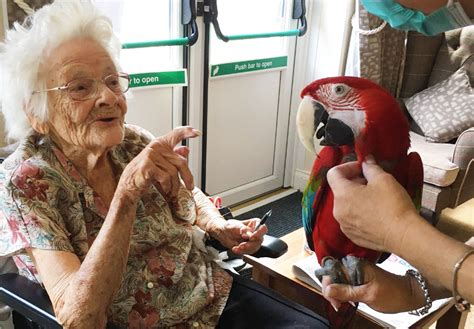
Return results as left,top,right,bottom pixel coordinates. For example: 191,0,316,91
322,263,424,313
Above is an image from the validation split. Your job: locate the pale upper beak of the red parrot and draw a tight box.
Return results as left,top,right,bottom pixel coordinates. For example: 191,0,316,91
296,96,316,153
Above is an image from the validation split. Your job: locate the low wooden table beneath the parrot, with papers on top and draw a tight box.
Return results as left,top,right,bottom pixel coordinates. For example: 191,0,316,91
244,228,467,329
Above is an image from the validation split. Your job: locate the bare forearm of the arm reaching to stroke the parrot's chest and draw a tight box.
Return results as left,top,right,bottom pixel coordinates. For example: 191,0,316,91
390,213,474,302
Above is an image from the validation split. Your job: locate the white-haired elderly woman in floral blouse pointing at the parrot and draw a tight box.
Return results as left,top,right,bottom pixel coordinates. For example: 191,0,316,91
0,0,326,328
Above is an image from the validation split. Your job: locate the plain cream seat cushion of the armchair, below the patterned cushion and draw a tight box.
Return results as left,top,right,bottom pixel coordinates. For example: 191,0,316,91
410,131,459,187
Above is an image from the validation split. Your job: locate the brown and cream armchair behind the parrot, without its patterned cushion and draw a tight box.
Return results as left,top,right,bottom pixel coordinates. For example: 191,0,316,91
400,25,474,223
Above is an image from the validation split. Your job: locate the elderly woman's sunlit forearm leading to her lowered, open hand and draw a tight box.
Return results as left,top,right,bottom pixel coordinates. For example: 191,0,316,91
193,188,225,238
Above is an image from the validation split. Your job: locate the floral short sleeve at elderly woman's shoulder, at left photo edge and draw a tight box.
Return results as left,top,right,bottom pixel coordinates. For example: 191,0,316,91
0,160,74,256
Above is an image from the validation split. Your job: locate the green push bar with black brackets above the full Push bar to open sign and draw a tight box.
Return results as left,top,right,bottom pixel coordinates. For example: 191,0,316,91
204,0,308,42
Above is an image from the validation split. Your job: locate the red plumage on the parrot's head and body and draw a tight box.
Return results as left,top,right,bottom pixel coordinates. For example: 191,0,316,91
301,77,423,328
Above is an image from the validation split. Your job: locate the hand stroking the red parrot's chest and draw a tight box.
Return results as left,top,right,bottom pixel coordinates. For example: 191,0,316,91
327,158,416,252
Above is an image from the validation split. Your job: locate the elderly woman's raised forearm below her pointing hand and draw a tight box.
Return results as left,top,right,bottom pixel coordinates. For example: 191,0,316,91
55,191,136,328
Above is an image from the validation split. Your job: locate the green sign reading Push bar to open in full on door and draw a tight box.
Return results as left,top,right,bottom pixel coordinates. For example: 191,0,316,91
211,56,288,77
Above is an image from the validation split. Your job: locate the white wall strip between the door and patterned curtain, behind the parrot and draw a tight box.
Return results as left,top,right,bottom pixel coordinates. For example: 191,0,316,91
290,0,354,190
